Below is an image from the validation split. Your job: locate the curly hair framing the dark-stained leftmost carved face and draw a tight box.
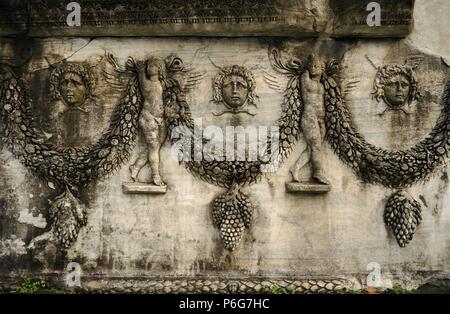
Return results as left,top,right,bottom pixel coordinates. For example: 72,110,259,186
50,62,95,99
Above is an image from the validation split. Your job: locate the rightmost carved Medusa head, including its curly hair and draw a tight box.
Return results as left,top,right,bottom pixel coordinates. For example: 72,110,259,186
372,65,422,110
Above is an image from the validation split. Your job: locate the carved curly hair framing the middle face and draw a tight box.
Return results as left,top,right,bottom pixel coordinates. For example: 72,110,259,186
213,65,258,106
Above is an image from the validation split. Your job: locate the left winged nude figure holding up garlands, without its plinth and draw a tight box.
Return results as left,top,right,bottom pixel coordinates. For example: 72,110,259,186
104,54,201,186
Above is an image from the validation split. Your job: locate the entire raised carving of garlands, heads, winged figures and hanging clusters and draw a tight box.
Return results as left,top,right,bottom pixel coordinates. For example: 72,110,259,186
0,36,450,260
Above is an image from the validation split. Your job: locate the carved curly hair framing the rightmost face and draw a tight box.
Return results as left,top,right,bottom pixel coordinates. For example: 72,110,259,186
372,64,422,104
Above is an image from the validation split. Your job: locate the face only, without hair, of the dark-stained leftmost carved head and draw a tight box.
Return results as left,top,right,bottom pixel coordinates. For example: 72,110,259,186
59,72,87,107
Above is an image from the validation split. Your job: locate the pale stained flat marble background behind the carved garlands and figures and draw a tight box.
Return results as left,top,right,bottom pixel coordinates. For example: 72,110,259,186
0,1,450,292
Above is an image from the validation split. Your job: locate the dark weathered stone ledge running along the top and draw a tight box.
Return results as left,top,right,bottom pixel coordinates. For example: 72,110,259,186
0,0,414,37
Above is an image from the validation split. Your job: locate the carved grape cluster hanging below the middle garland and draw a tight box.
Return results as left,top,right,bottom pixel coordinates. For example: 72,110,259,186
212,190,253,251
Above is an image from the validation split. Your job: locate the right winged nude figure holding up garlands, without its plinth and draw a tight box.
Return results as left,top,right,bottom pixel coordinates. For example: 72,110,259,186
264,49,359,185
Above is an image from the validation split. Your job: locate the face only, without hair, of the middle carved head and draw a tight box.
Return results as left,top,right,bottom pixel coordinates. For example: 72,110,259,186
222,75,248,109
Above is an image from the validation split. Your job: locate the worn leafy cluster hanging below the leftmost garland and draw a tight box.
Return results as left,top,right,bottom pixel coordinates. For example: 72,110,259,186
49,189,87,249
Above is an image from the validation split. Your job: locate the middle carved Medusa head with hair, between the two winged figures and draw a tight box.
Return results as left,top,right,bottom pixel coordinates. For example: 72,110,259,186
213,65,258,115
